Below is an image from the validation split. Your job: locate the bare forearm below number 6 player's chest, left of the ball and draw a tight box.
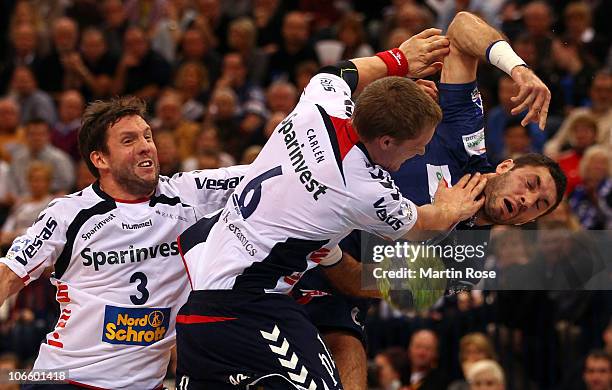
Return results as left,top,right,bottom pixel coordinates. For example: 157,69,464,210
323,252,380,298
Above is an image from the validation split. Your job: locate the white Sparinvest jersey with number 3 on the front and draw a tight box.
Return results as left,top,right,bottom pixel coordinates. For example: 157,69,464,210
0,166,246,389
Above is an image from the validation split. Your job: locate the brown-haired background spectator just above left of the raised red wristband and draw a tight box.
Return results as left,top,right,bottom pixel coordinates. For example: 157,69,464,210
315,12,374,66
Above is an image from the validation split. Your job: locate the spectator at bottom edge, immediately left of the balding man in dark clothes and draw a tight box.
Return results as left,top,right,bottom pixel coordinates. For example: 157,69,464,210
374,347,410,390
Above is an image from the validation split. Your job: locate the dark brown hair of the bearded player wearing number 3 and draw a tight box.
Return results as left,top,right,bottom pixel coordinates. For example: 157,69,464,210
79,96,147,178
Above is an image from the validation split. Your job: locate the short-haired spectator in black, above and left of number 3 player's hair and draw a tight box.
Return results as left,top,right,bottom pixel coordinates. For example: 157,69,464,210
35,17,80,96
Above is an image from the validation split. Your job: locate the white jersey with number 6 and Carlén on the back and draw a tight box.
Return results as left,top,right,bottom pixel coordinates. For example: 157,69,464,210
179,73,417,293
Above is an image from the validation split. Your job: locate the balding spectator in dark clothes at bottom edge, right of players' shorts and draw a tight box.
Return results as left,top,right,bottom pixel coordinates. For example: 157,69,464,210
408,329,447,390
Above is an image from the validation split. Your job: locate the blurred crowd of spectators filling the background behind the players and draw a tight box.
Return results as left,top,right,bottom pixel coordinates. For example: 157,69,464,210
0,0,612,390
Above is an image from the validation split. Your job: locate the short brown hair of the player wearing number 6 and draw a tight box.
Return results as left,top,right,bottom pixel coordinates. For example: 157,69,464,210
353,76,442,141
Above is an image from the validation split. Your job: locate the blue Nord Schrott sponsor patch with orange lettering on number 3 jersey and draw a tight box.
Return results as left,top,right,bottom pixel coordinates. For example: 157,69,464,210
102,305,170,345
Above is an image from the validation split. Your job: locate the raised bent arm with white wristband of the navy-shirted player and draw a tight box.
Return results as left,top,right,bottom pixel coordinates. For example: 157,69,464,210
441,12,551,129
